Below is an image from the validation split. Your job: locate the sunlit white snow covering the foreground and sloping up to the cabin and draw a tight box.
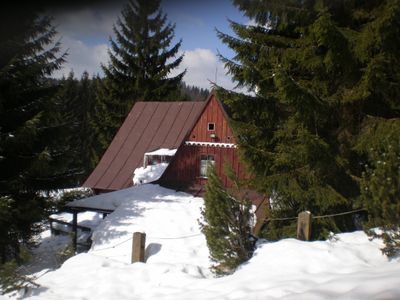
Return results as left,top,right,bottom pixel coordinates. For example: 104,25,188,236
5,185,400,300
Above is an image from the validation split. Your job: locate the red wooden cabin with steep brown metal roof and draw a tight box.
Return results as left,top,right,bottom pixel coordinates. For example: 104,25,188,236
84,92,267,227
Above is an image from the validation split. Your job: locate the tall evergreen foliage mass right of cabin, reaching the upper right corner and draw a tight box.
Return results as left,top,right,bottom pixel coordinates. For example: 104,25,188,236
218,0,400,239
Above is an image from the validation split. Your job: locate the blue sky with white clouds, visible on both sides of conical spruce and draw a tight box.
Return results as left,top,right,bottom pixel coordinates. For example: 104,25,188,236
49,0,248,88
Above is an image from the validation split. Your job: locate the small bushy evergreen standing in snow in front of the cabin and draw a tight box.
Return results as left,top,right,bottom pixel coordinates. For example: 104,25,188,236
201,167,254,275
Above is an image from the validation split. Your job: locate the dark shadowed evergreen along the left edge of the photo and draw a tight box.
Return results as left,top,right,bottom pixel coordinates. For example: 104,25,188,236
0,13,65,262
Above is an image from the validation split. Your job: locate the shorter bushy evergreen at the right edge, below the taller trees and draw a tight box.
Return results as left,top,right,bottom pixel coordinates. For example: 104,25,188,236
361,119,400,256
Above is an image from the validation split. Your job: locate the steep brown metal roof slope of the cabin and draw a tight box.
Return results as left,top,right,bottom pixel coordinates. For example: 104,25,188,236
83,102,205,190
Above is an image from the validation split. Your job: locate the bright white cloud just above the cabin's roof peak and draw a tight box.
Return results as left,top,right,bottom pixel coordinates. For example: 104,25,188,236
171,48,238,89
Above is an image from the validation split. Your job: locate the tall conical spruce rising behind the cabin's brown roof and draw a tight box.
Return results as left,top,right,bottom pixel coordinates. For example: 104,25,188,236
95,0,184,149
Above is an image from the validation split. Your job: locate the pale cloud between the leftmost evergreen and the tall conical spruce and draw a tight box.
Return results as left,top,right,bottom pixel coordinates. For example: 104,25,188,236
53,37,108,78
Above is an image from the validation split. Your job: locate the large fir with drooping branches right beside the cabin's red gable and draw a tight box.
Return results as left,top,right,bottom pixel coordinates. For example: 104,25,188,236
218,1,366,239
